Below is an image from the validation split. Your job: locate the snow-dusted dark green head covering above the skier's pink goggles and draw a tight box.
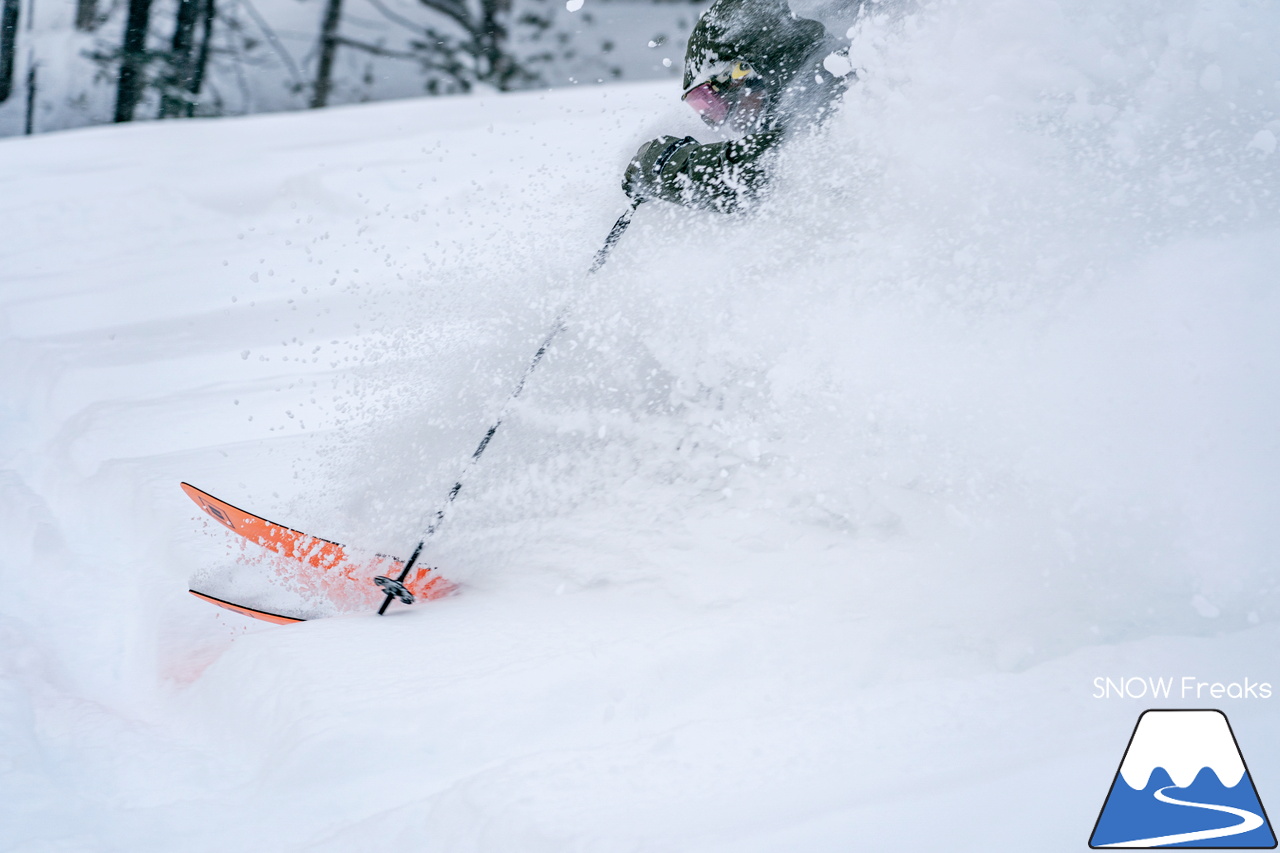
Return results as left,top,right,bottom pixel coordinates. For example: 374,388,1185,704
684,0,827,102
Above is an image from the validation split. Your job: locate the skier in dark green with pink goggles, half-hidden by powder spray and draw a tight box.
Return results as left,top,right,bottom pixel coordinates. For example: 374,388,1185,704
622,0,845,213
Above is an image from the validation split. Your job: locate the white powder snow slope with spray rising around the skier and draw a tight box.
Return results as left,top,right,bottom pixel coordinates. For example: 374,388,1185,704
0,0,1280,852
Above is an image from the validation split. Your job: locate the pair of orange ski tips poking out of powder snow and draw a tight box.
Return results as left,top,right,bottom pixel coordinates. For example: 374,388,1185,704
182,483,457,624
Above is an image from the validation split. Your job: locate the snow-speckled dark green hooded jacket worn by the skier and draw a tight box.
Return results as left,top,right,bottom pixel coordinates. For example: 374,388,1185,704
650,0,845,213
